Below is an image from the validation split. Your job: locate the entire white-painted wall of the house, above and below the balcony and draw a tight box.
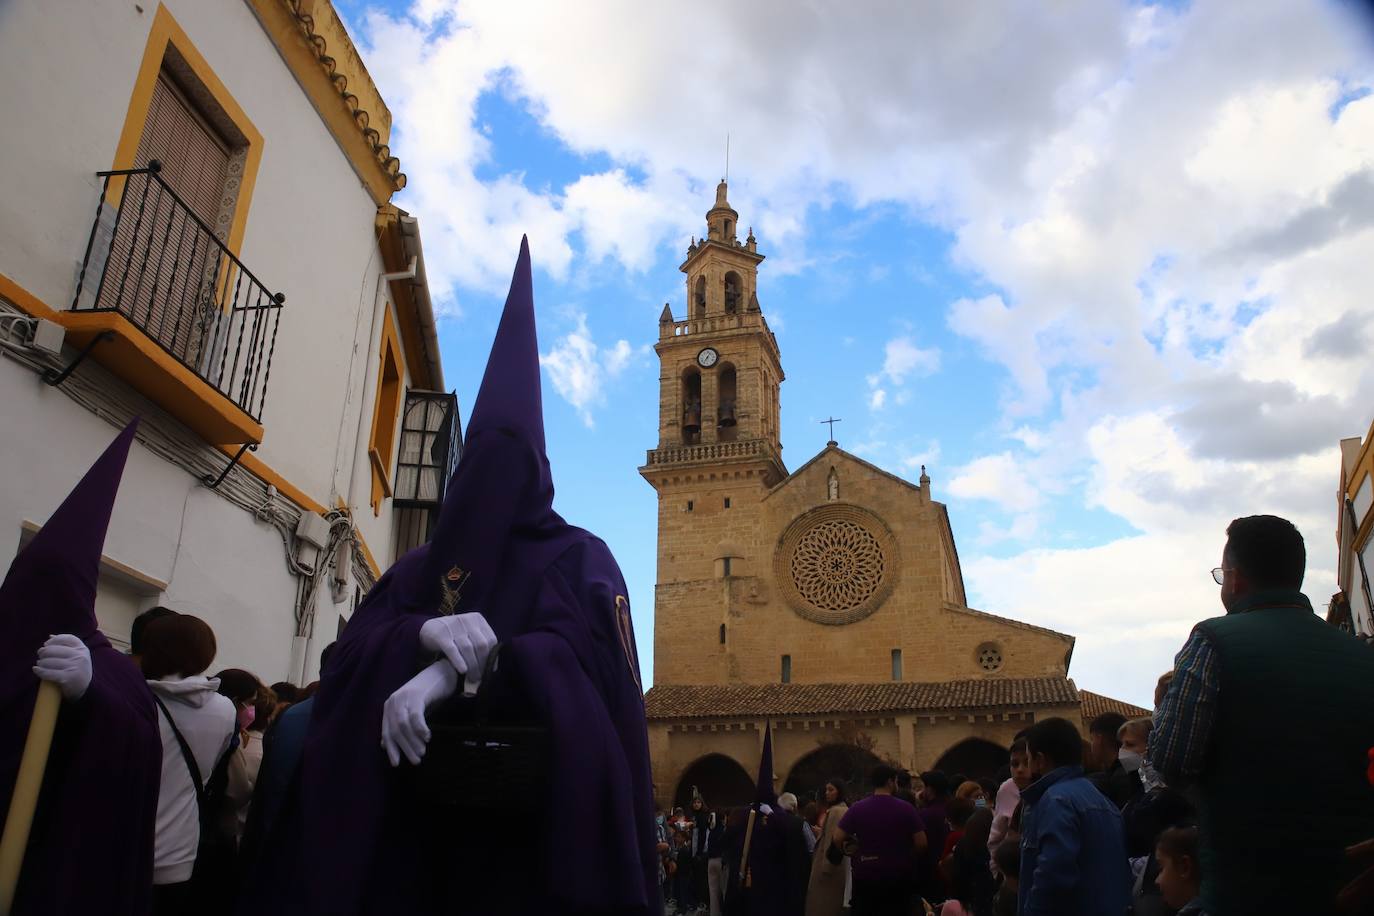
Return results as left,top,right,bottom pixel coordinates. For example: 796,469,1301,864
0,0,434,681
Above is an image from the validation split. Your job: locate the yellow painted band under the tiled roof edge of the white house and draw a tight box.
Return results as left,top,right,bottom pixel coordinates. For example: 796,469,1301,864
247,0,405,206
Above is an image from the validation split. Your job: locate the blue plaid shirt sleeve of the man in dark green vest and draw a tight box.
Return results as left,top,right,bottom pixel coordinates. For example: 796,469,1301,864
1147,629,1220,783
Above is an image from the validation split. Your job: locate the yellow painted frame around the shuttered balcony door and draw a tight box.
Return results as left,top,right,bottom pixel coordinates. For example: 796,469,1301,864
106,3,262,260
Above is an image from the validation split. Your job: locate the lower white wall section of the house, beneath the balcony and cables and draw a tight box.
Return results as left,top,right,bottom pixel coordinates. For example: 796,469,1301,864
0,360,295,683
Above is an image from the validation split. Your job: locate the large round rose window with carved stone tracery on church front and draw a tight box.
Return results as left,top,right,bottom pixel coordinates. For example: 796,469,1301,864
778,505,897,623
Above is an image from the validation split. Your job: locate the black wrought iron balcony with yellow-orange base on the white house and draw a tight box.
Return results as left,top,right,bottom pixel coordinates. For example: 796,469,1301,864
63,161,286,444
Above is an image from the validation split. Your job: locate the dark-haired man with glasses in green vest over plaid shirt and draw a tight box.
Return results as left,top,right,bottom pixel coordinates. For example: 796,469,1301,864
1149,515,1374,916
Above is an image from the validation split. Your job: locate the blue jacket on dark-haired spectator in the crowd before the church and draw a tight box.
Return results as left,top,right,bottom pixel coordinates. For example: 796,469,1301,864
1017,766,1131,916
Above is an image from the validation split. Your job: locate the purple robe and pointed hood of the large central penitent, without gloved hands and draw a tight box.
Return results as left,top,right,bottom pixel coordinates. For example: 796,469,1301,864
269,240,658,915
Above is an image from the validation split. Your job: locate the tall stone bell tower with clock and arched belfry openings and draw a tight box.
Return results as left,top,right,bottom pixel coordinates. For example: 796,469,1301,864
639,181,787,684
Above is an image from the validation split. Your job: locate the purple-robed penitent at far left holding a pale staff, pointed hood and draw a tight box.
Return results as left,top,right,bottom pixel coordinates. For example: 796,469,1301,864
0,423,162,916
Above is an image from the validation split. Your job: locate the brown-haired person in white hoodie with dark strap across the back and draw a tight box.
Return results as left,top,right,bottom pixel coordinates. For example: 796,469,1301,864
142,614,238,916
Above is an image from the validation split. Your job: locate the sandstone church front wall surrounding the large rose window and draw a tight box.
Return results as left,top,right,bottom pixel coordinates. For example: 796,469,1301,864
654,449,1069,684
